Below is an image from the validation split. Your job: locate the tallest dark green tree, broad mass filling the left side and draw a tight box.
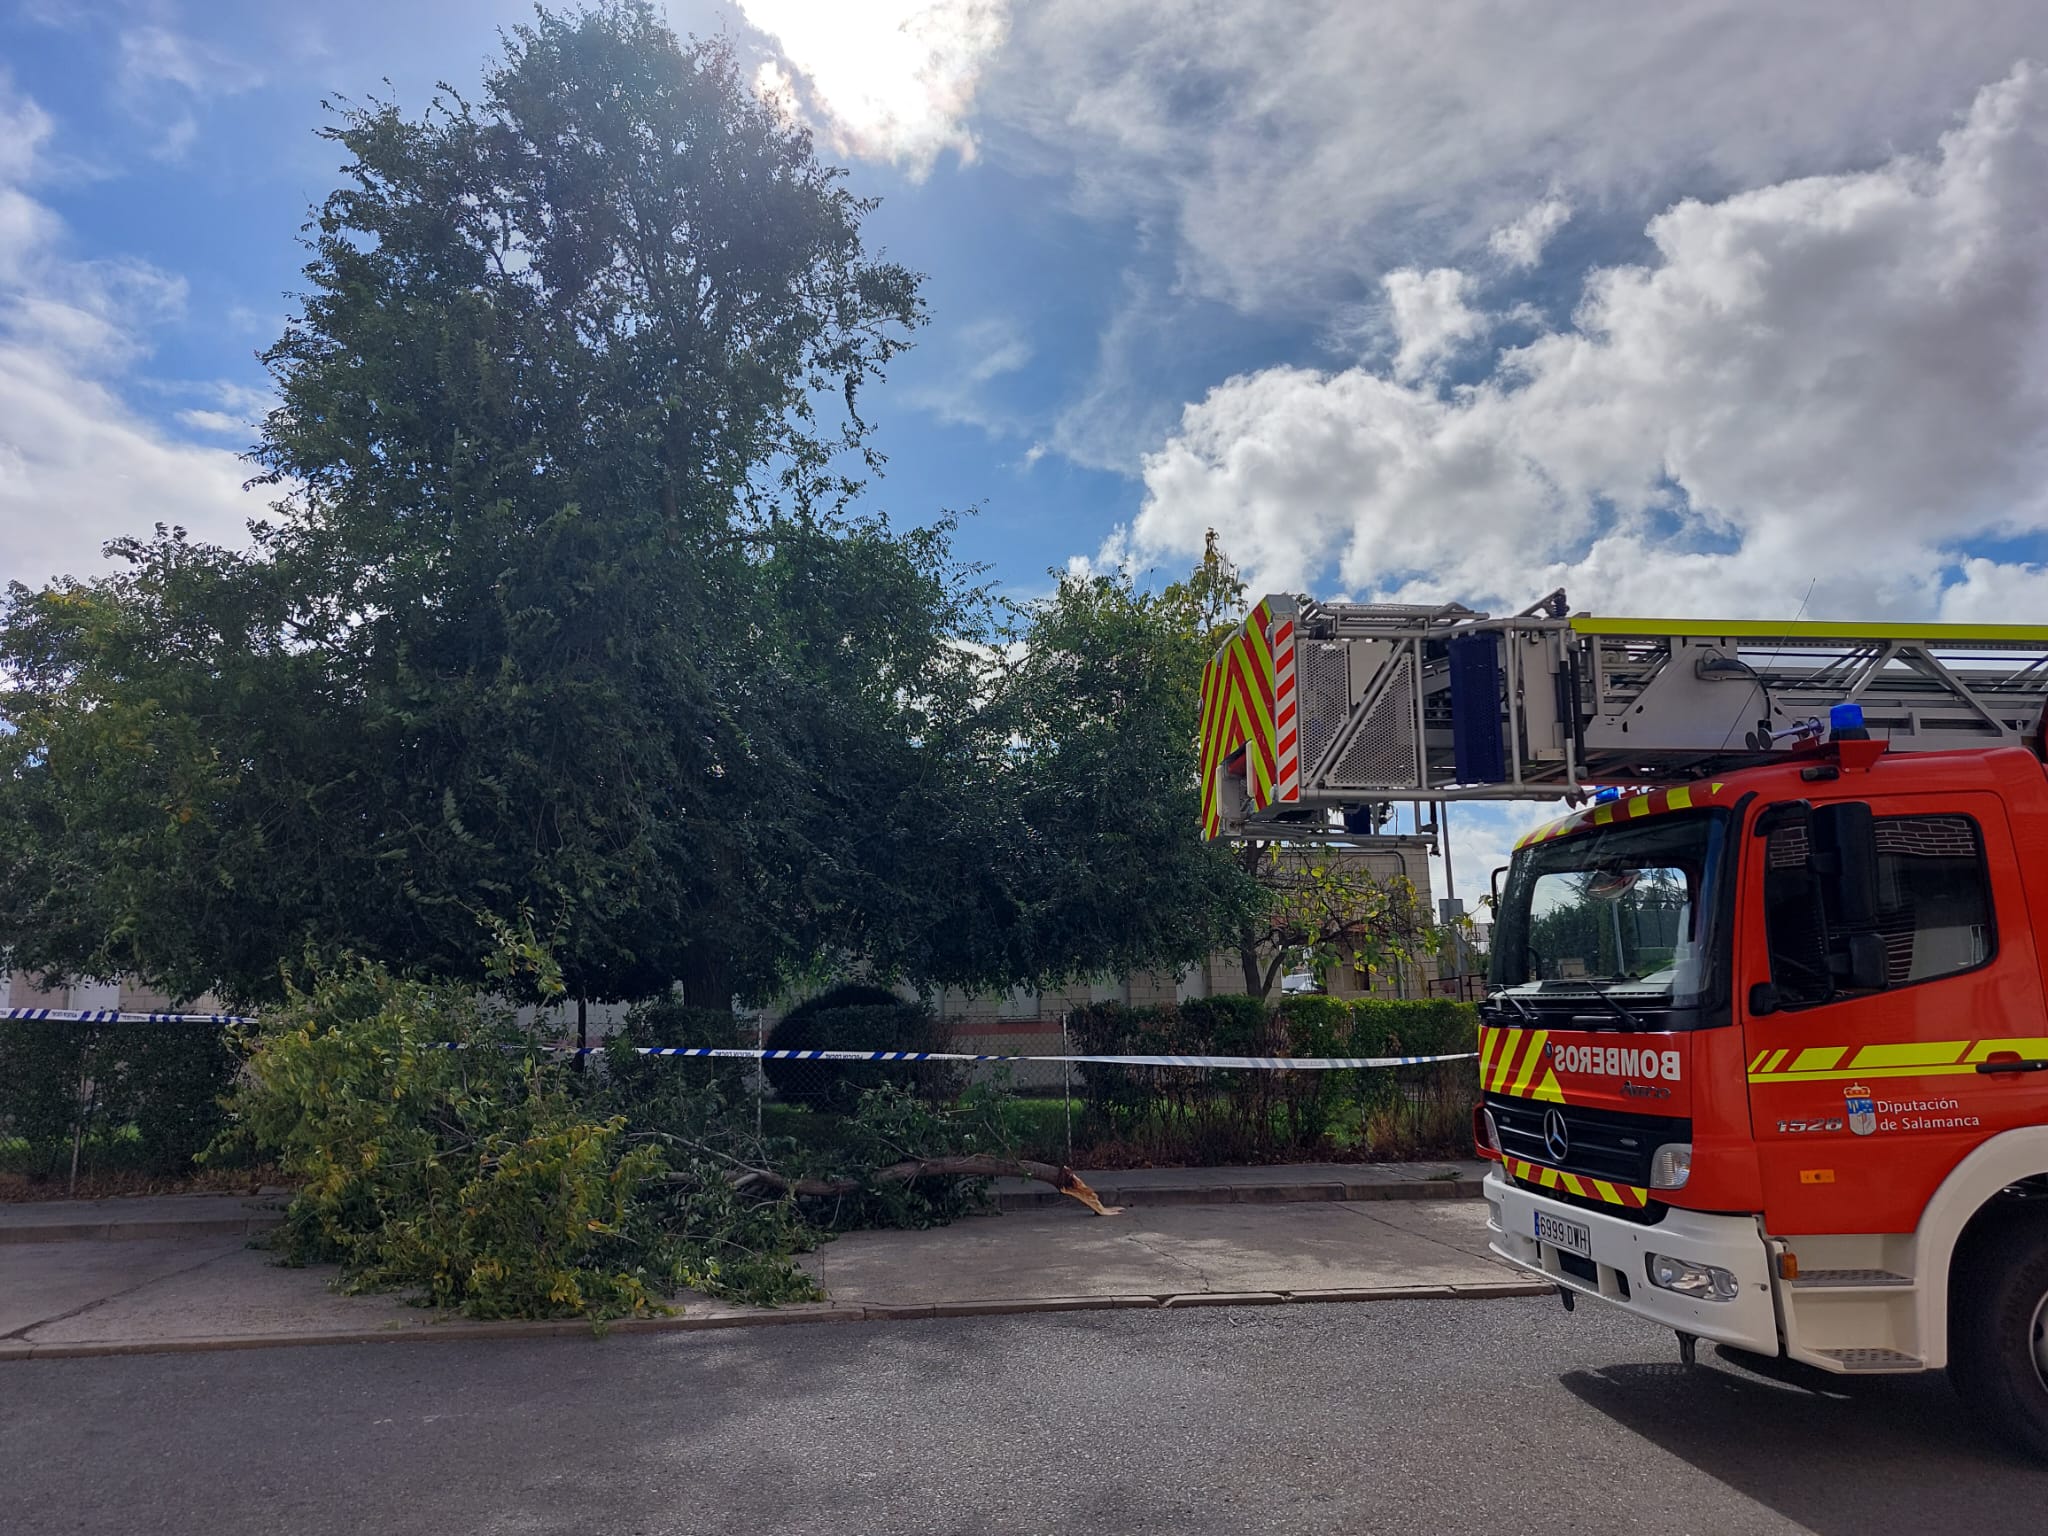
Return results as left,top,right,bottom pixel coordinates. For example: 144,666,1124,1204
0,0,975,1001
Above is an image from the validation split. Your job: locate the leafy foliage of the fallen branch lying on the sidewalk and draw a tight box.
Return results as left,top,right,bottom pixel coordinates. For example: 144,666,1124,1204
213,942,1040,1321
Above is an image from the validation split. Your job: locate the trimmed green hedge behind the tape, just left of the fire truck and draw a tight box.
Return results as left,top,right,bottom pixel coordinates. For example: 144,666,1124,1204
1067,995,1479,1163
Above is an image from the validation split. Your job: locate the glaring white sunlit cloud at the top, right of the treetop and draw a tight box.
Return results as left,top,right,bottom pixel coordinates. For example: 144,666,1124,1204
737,0,1010,178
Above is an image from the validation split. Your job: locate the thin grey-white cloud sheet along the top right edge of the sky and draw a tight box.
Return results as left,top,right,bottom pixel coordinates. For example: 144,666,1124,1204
978,0,2048,313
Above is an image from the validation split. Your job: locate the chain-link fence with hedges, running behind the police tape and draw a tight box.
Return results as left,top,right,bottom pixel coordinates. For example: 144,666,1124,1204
0,997,1477,1180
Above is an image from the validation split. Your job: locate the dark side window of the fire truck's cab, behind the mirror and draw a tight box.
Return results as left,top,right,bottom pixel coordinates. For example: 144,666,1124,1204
1763,815,1995,1008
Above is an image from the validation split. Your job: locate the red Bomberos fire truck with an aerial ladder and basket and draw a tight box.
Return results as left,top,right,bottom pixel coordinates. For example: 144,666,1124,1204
1202,594,2048,1456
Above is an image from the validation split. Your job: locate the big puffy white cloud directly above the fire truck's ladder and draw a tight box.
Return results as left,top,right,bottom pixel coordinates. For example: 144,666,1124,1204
1130,68,2048,616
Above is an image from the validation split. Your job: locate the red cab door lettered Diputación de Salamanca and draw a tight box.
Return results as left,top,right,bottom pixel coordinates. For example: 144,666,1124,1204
1739,795,2048,1235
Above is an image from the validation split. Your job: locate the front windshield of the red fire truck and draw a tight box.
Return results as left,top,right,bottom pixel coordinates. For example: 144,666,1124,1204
1493,811,1729,1028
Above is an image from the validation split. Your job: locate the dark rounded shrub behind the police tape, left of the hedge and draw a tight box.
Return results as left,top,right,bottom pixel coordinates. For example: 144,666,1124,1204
762,983,961,1114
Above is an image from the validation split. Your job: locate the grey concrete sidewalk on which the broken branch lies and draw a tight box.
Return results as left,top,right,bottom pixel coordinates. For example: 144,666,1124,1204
0,1184,1546,1360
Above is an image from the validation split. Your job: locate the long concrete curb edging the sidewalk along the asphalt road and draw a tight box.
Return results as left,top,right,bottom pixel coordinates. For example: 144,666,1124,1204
0,1280,1556,1362
